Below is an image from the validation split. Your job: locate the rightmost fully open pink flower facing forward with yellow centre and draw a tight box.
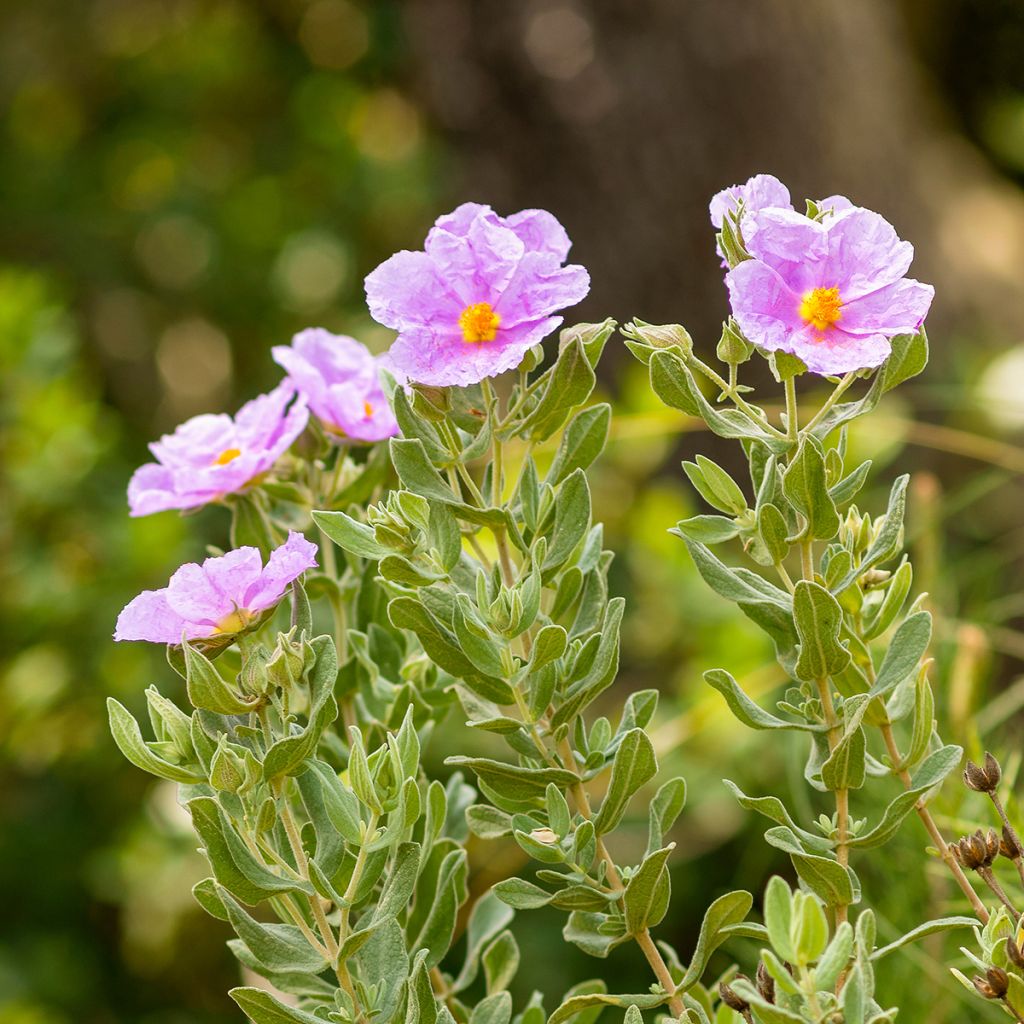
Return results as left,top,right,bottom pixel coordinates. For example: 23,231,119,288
725,197,935,376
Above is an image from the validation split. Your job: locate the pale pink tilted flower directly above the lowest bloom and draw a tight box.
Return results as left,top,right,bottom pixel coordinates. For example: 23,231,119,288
128,380,309,516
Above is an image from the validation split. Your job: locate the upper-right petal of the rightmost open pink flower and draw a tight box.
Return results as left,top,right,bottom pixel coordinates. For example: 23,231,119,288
821,208,913,304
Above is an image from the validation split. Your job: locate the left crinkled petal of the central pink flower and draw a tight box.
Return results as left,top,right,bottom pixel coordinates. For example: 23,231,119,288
365,250,466,331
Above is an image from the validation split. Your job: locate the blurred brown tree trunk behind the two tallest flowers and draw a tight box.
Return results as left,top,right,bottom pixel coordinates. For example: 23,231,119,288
407,0,1024,358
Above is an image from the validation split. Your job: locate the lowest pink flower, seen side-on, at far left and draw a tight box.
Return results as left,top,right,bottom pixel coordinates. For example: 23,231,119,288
114,532,316,644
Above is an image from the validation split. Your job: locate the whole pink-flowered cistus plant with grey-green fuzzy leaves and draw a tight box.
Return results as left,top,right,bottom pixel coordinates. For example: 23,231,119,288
110,188,991,1024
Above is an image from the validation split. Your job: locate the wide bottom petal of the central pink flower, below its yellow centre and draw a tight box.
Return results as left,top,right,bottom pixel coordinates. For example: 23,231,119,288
389,316,562,387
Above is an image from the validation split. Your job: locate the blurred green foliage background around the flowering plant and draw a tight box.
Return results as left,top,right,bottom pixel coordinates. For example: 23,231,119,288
6,0,1024,1024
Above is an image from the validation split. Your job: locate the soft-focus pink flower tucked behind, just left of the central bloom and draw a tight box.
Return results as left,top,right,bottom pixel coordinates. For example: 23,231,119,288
272,328,398,441
